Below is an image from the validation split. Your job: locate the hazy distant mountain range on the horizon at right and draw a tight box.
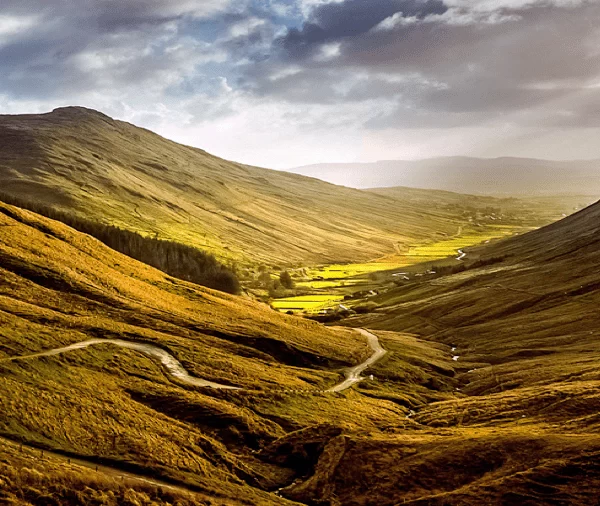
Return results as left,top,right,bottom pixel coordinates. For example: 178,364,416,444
289,156,600,196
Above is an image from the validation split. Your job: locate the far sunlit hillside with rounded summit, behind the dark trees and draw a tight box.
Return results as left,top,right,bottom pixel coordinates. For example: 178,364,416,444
0,108,476,264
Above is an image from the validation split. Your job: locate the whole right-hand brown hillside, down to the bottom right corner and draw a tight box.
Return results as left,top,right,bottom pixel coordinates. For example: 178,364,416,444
290,204,600,505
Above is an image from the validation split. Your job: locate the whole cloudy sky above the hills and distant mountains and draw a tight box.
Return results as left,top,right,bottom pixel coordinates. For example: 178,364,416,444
0,0,600,168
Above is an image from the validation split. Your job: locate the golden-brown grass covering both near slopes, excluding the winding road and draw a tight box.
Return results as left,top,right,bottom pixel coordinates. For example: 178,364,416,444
0,181,600,506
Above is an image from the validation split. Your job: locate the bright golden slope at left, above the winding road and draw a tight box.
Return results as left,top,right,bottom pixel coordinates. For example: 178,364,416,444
0,203,367,388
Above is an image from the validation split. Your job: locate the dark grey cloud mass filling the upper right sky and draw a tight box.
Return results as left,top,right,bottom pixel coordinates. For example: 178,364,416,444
241,0,600,128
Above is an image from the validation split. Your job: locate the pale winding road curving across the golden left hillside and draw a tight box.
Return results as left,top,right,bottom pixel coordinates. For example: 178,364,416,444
0,329,386,392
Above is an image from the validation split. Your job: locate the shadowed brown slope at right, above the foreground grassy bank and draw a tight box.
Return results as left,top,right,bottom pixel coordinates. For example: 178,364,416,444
350,200,600,393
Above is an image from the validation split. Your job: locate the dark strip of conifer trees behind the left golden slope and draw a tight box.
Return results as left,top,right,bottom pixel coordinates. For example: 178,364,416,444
0,193,241,294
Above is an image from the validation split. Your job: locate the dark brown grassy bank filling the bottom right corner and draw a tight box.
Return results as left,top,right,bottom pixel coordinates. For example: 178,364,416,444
285,426,600,506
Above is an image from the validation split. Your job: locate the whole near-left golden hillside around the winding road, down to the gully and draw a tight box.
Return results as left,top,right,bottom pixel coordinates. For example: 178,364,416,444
0,200,462,505
